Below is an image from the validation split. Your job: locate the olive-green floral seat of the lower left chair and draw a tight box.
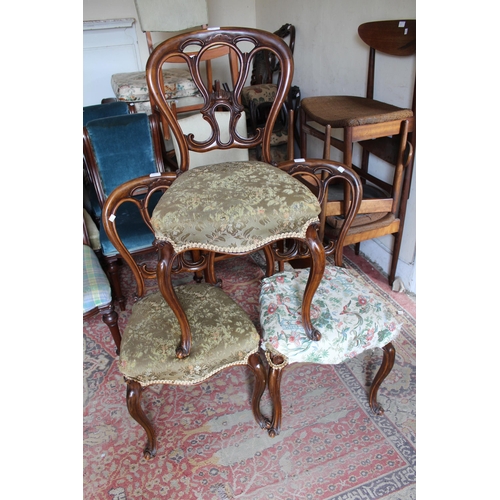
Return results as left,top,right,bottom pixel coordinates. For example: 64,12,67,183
119,283,260,386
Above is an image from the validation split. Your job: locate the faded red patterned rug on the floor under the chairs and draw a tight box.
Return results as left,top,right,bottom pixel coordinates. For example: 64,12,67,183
83,250,416,500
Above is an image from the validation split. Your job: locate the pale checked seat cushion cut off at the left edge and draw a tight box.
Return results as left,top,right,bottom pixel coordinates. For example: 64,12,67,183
83,245,111,314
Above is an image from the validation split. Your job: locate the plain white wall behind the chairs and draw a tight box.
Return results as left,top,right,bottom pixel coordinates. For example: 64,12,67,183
83,0,417,292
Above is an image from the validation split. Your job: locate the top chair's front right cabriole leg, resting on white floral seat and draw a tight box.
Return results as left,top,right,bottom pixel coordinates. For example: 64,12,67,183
302,226,326,340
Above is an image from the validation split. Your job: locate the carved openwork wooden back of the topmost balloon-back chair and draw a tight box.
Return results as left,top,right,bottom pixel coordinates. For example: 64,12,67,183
146,28,293,171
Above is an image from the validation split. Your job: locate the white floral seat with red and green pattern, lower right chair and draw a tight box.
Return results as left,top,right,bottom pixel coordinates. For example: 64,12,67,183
260,265,401,366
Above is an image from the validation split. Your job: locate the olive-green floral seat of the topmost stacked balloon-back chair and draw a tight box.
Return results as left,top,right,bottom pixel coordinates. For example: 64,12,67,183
151,161,321,253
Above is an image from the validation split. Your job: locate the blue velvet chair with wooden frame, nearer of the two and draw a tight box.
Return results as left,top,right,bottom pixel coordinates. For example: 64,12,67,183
83,111,165,310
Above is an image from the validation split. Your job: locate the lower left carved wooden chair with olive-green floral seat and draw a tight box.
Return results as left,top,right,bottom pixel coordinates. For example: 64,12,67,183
103,172,268,460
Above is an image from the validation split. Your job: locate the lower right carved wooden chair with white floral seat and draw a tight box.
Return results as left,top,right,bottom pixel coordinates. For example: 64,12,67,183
259,160,401,437
